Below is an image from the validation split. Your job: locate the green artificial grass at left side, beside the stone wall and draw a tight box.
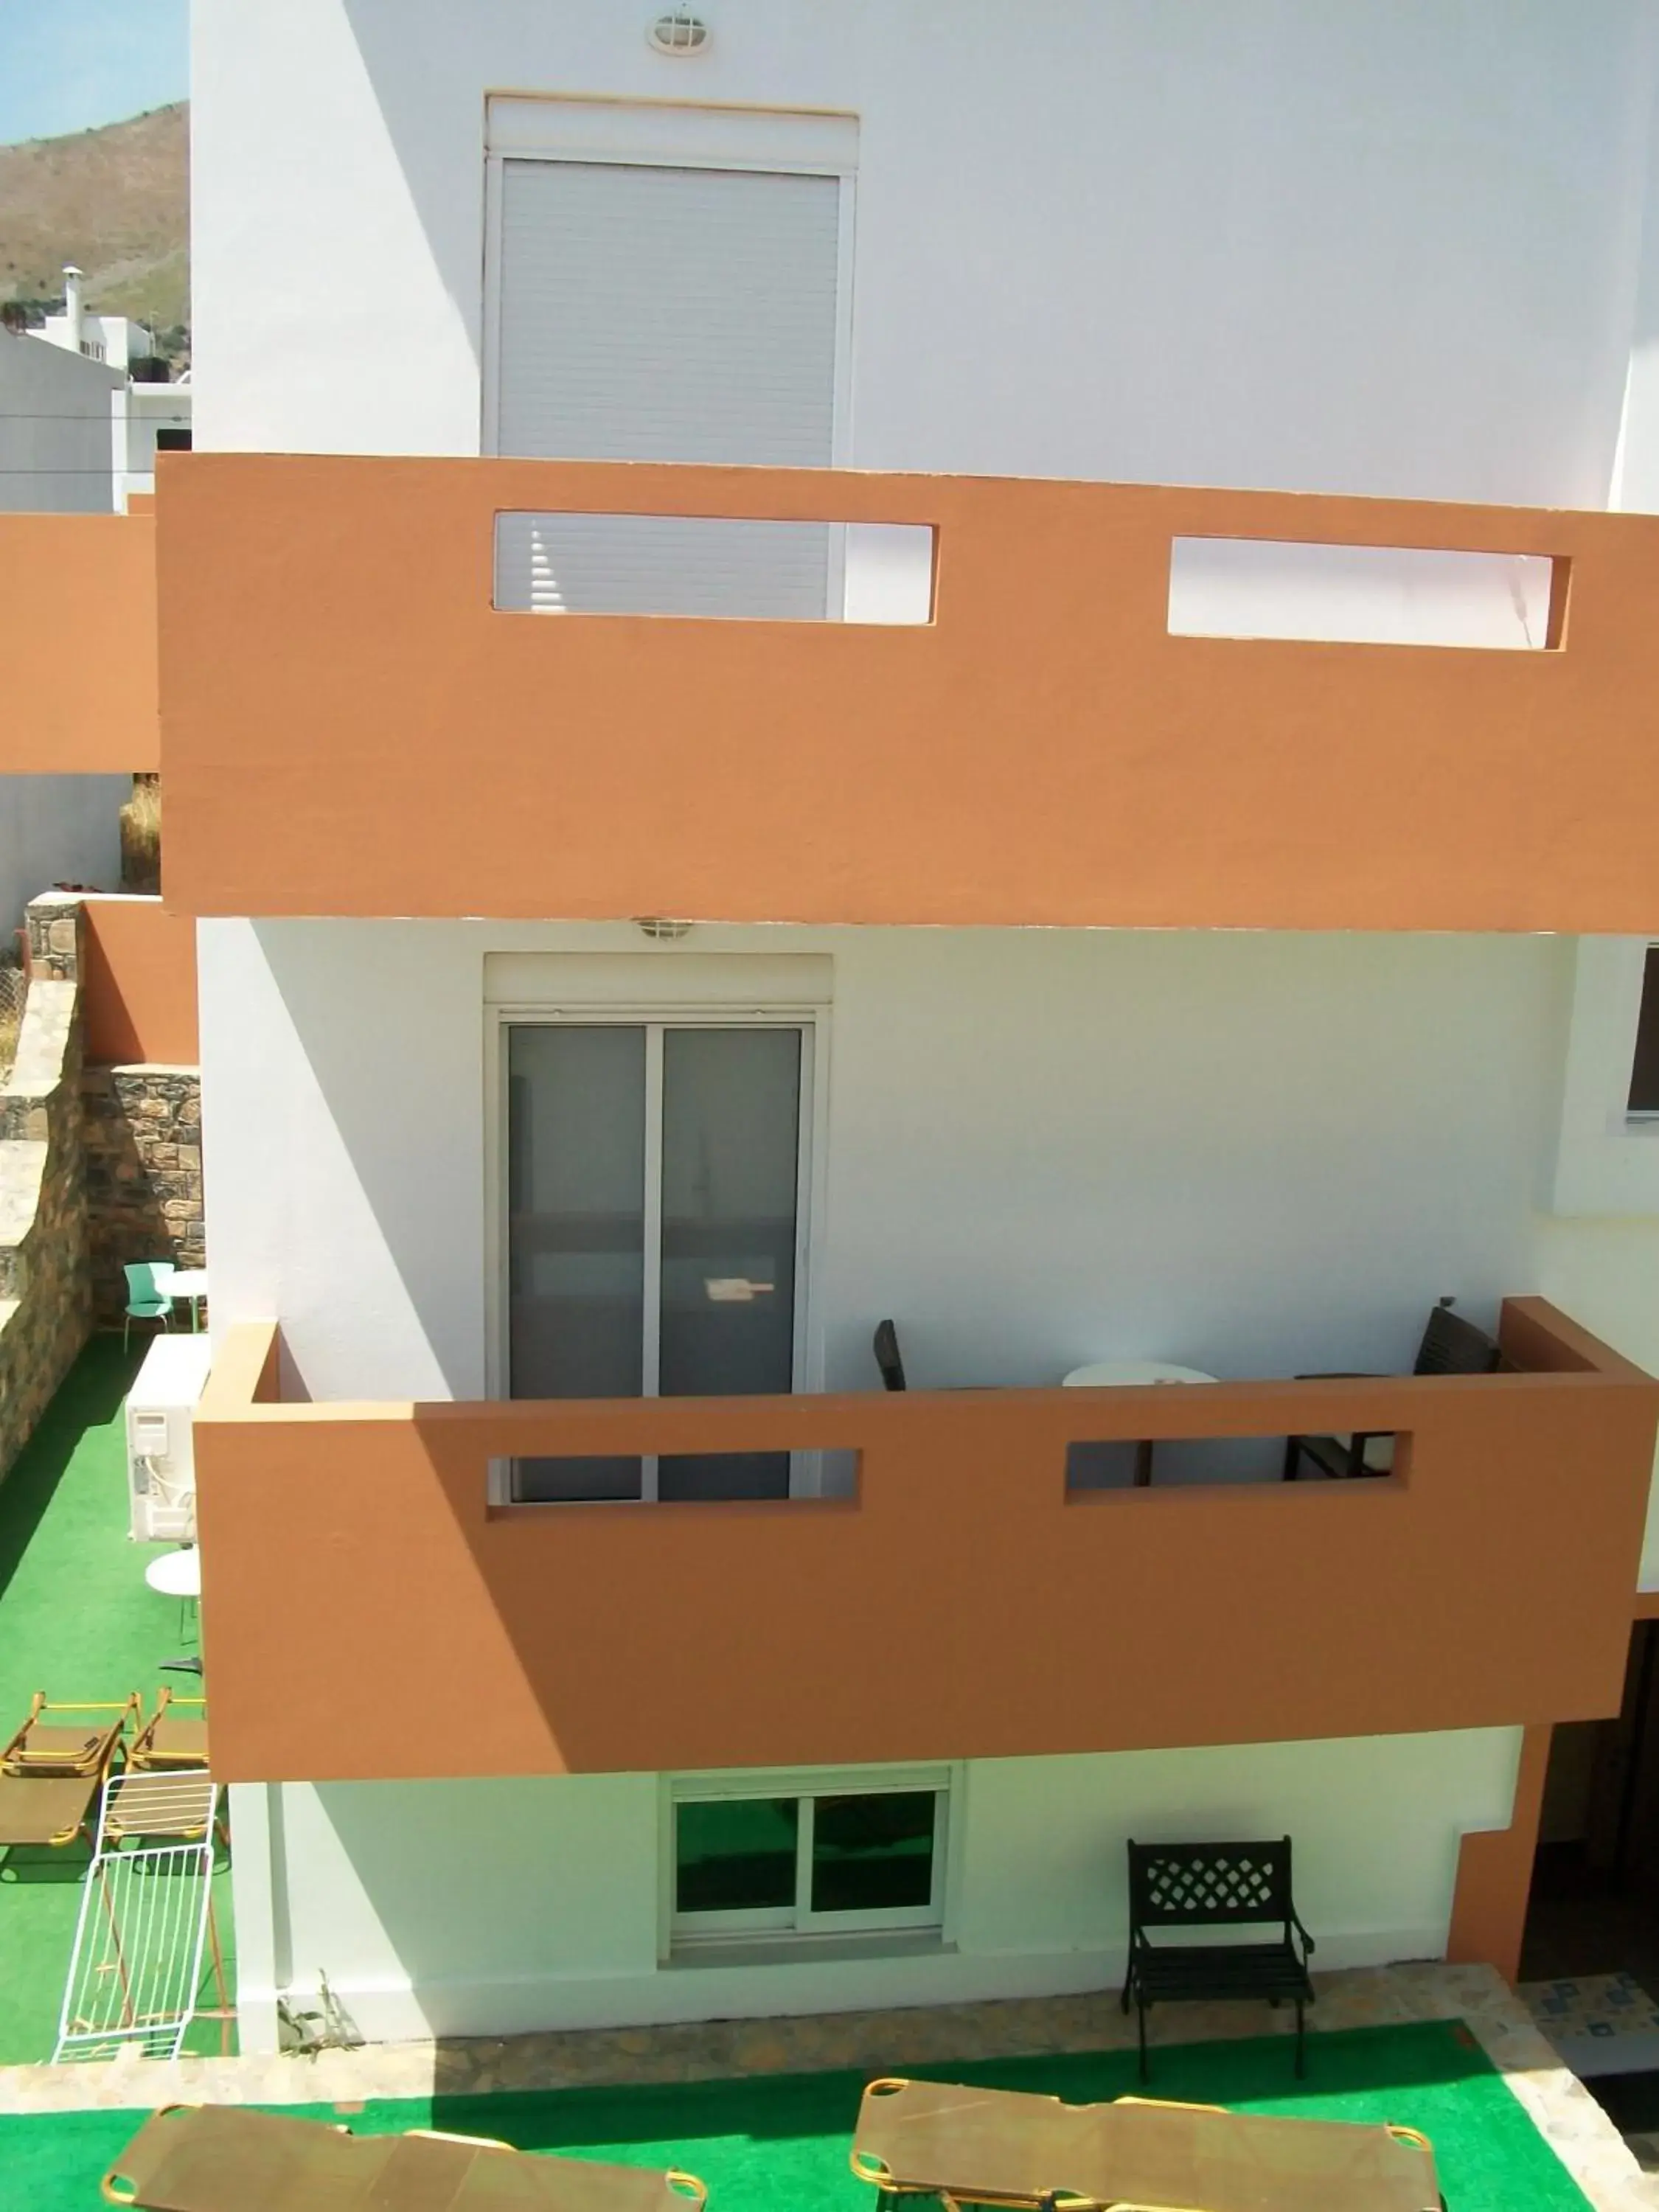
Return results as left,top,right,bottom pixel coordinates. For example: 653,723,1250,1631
0,1332,234,2070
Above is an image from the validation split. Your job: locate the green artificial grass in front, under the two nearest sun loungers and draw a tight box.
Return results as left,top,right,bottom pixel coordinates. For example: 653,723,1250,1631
0,2022,1586,2212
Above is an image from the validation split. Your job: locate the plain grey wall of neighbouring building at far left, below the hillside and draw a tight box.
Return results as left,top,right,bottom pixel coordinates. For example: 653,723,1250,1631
0,332,124,515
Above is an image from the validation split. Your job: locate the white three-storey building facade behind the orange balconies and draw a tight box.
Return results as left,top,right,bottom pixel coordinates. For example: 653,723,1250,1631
192,0,1659,2046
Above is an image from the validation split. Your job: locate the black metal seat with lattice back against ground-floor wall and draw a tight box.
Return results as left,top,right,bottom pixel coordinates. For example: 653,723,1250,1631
1121,1836,1314,2081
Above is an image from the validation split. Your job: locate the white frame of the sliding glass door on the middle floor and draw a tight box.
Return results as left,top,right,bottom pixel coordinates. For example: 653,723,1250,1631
484,987,830,1513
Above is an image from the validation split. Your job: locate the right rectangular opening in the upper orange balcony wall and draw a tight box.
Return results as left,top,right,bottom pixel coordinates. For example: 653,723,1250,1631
1168,538,1568,653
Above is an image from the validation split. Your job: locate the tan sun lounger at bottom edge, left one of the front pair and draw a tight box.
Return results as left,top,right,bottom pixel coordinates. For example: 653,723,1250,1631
104,2104,708,2212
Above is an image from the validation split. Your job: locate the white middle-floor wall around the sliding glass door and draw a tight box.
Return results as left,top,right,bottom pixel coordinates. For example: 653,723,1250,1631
199,920,1571,1398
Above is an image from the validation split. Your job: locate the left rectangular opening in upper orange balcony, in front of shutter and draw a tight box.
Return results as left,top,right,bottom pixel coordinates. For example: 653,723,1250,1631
495,513,936,626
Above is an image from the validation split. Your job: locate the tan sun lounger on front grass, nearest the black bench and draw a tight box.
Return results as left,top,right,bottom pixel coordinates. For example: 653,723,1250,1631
852,2081,1440,2212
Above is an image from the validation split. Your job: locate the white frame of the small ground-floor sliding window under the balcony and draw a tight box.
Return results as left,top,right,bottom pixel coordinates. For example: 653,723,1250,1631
657,1765,962,1960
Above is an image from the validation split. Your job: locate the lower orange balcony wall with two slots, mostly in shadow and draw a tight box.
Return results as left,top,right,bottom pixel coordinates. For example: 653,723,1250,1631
197,1301,1659,1781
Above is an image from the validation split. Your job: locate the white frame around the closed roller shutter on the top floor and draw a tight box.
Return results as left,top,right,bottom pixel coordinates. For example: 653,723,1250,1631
480,95,858,467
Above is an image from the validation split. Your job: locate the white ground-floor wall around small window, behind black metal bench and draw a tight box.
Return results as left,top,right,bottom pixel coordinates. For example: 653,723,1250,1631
232,1728,1520,2048
